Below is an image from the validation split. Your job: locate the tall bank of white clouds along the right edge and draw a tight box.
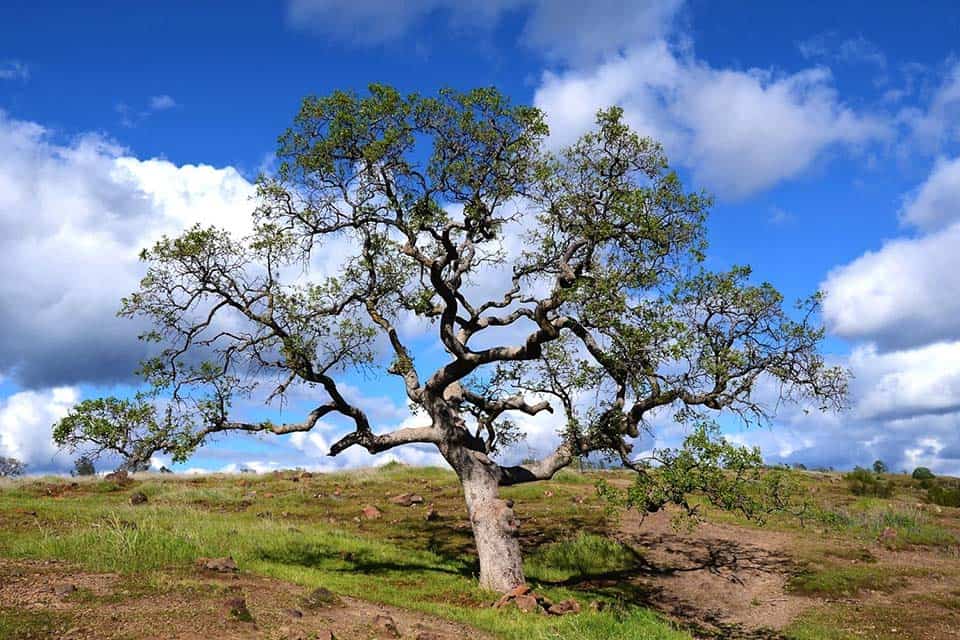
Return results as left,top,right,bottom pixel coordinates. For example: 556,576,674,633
800,159,960,474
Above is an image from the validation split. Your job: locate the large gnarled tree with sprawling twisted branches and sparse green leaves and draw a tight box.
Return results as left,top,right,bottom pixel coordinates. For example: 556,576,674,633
52,86,846,591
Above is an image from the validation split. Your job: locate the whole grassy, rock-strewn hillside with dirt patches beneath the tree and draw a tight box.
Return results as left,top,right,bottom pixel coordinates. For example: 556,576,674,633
0,465,960,640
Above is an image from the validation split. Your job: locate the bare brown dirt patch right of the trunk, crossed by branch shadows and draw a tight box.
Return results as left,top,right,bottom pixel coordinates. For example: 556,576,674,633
620,511,817,638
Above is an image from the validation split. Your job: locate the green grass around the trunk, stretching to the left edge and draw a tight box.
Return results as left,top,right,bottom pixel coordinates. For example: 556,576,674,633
0,466,690,640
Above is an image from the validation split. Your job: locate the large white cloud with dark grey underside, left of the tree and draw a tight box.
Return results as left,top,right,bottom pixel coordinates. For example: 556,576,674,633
0,112,253,388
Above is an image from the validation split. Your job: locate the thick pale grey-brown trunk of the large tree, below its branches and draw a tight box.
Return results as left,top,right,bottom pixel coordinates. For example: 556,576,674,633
454,452,525,592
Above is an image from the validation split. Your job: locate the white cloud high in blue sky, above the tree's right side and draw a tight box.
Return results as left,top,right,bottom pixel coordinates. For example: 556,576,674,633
535,40,889,198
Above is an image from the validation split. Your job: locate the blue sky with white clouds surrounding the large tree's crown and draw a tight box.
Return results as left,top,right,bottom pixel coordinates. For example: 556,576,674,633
0,0,960,473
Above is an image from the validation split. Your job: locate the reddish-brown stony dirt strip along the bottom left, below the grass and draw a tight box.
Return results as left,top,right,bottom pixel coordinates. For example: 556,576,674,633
0,559,490,640
